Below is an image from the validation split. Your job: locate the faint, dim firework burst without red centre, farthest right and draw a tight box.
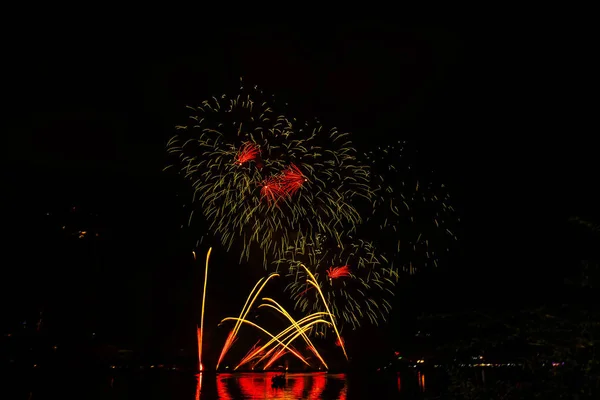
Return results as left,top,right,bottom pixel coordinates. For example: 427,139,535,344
357,141,460,275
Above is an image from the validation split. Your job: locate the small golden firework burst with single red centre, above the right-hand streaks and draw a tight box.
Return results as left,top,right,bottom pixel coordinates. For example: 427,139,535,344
277,237,398,333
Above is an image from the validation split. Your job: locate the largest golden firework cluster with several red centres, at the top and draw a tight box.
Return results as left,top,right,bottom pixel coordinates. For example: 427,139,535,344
167,78,372,265
